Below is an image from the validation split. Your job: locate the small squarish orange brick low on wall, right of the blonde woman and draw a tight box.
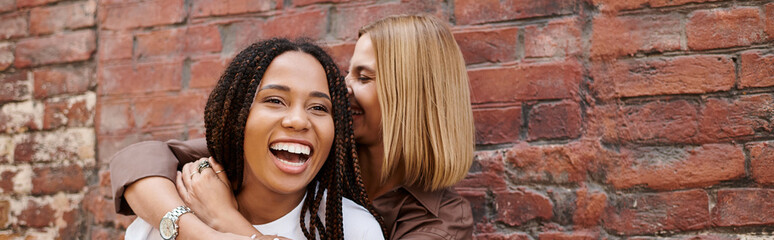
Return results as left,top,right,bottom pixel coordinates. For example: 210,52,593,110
572,187,607,228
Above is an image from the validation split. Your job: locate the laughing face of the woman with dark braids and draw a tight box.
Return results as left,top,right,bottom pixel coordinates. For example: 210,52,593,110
244,51,334,194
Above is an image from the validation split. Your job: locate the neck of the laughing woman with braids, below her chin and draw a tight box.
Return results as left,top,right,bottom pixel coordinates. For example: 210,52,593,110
236,168,306,225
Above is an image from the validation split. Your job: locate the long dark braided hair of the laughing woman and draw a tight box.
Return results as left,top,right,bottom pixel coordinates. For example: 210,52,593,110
204,38,387,239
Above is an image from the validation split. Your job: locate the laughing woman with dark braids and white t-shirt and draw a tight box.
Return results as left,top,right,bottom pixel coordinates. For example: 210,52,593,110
121,38,384,239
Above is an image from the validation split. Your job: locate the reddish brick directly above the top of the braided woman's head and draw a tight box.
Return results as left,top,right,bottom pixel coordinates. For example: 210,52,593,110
261,10,328,39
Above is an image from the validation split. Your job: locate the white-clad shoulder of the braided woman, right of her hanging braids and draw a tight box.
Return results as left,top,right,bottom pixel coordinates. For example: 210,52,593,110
341,198,384,239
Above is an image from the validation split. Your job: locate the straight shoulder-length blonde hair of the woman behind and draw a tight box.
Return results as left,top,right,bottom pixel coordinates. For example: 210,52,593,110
359,15,475,191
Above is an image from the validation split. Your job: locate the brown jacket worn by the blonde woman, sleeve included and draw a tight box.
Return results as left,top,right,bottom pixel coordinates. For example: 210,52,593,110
110,139,473,239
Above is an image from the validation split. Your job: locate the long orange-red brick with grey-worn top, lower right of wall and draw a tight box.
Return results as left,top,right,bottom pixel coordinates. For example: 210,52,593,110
607,144,745,190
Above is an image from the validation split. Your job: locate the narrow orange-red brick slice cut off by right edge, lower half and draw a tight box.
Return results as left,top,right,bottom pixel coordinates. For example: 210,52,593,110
745,142,774,185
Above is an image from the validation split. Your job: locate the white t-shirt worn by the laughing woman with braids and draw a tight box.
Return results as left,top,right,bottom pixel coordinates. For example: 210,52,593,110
125,196,384,240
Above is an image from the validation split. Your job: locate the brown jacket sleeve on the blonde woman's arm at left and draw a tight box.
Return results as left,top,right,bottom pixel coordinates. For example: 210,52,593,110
110,139,210,215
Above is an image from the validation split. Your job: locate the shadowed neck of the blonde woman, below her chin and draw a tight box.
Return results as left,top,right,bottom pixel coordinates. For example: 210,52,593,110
357,143,403,200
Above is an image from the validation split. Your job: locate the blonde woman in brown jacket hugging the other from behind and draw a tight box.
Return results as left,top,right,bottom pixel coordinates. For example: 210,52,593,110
111,15,474,239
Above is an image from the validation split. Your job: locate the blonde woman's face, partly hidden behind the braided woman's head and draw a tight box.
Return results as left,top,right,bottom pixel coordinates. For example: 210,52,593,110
346,34,382,145
